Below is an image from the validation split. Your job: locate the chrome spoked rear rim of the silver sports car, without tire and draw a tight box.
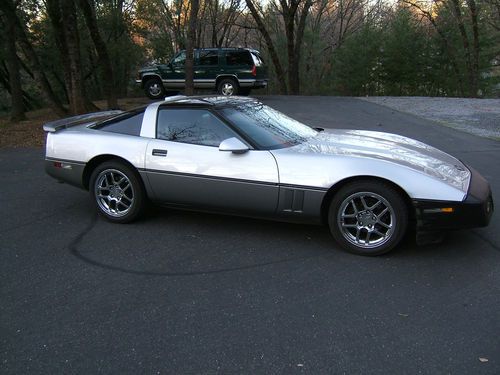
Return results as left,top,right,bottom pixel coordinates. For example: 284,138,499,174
94,169,134,217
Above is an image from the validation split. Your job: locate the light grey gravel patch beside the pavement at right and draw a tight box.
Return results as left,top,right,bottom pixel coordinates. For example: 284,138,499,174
360,96,500,140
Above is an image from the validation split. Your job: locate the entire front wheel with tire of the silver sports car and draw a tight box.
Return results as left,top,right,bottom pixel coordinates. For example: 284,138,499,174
328,180,408,256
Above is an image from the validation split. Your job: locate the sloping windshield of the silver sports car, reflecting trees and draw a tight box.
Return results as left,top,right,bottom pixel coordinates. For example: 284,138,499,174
220,102,318,150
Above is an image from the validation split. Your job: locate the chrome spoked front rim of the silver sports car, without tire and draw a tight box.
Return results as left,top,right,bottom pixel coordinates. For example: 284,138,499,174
337,192,396,249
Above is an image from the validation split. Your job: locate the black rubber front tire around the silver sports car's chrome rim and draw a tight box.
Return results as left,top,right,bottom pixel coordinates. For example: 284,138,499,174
328,181,408,256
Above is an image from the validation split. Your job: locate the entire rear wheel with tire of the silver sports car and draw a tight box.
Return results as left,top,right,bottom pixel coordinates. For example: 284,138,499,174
89,160,146,223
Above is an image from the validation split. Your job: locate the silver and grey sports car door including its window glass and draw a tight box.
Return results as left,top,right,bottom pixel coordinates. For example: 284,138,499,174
145,107,279,215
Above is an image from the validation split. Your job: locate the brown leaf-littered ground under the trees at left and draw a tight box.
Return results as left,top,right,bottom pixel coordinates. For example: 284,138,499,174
0,98,151,148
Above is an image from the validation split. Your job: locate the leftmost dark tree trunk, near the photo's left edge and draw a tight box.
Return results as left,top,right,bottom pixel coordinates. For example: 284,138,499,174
4,10,26,122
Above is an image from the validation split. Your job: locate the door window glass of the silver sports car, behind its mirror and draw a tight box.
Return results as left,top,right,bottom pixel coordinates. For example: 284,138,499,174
156,108,240,147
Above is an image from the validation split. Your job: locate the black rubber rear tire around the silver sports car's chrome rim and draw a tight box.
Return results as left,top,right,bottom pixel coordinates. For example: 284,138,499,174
89,161,145,223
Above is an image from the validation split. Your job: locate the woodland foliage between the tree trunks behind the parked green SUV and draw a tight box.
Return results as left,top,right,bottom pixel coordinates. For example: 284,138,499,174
0,0,500,114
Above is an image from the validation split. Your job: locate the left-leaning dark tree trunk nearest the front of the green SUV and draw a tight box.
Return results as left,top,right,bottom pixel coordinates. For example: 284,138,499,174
78,0,118,109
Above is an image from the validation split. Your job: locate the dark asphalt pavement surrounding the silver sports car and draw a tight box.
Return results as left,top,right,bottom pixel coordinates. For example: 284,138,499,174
0,97,500,374
